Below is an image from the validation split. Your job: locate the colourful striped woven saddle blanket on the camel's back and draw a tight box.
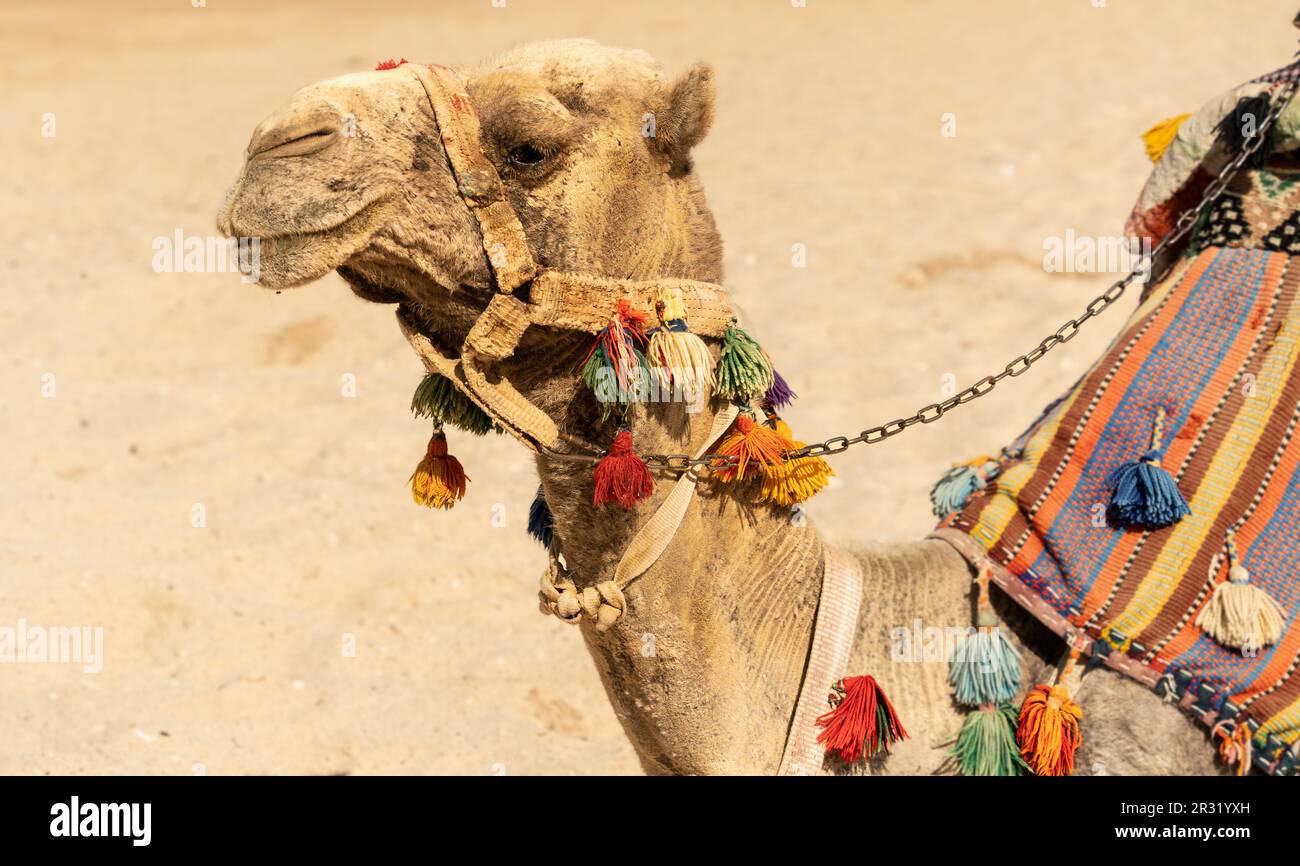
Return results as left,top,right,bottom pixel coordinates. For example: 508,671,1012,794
935,60,1300,775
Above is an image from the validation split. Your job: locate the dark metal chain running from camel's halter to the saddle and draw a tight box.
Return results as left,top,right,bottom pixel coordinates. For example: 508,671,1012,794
546,77,1300,472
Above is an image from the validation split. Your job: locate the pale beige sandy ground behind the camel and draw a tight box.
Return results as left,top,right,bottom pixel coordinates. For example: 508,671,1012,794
0,0,1296,774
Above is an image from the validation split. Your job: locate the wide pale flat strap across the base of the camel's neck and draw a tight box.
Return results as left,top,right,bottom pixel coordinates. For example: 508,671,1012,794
776,545,862,776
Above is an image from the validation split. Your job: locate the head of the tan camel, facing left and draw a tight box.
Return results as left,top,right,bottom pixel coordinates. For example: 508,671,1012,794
217,40,722,338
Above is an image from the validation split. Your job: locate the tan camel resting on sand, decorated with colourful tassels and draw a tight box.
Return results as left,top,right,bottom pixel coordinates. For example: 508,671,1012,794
218,40,1222,775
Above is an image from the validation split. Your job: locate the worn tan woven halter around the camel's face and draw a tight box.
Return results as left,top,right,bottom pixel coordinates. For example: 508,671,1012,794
398,64,732,455
